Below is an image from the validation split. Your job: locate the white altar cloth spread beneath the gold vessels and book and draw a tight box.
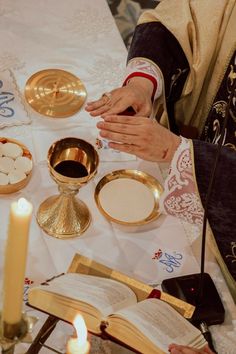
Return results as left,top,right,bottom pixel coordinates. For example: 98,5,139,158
0,0,236,354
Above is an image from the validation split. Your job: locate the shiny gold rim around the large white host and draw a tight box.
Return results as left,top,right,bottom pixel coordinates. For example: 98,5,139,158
94,170,163,226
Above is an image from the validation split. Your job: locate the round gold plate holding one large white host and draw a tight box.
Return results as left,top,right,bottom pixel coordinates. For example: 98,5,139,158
94,170,163,225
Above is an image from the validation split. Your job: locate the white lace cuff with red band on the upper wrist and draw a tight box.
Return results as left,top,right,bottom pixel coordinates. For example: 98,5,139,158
124,58,162,100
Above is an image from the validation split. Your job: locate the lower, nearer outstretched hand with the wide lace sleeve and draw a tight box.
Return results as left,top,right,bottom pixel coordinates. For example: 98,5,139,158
97,115,180,162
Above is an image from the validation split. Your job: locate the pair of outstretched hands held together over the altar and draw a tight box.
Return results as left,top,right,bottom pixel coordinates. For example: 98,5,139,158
85,78,180,162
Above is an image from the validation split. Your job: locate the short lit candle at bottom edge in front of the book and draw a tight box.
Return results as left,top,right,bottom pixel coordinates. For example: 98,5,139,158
67,315,90,354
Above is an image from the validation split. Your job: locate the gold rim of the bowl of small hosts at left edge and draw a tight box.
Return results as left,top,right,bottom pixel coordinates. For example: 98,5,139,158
0,137,33,194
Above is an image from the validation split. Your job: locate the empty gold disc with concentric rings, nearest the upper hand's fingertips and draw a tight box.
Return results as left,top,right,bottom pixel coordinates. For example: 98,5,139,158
25,69,86,118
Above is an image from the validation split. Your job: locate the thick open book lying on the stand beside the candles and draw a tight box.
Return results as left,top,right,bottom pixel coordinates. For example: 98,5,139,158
28,258,206,354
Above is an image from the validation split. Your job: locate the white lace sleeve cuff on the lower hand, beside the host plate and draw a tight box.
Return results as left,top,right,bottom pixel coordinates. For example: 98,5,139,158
160,137,203,224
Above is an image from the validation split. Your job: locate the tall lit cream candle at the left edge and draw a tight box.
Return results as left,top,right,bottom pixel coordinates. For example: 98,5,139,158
2,198,32,325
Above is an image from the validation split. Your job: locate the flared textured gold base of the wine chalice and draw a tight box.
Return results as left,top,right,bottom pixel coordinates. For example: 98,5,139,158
37,194,91,239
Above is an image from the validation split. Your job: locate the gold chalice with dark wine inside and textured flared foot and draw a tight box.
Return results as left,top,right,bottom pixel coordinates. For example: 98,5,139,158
37,138,99,238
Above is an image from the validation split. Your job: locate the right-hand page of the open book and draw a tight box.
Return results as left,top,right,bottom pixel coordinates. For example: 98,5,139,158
110,299,204,352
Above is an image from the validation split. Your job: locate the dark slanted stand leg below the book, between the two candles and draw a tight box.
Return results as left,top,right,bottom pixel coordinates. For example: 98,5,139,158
25,316,59,354
